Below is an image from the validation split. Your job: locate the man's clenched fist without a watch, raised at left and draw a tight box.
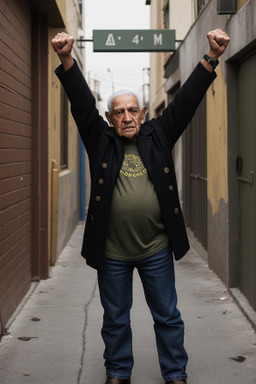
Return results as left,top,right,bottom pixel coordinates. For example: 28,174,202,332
52,32,74,71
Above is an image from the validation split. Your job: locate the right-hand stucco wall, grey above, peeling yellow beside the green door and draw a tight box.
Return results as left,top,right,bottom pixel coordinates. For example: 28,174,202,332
177,0,256,286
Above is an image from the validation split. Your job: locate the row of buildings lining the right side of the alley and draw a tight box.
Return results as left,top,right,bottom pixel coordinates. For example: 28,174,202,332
146,0,256,326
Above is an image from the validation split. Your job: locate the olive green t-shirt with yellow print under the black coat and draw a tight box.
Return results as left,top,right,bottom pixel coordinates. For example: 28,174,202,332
106,139,169,261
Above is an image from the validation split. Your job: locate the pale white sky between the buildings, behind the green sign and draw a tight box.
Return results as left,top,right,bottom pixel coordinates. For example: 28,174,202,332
84,0,150,108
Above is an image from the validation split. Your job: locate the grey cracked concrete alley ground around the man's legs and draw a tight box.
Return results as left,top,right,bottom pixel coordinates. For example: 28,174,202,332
0,223,256,384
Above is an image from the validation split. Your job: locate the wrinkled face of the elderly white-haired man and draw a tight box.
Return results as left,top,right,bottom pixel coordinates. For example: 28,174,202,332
106,95,146,139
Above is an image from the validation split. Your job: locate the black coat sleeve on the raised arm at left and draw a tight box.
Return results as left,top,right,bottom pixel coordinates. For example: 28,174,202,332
55,61,108,155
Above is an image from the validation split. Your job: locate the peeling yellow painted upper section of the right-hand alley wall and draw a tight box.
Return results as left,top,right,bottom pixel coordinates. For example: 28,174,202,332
207,61,228,215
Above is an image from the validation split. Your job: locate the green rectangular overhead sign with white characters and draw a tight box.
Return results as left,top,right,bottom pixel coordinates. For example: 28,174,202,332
93,29,175,52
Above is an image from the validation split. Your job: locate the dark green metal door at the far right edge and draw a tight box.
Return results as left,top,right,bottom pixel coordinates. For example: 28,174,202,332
236,55,256,309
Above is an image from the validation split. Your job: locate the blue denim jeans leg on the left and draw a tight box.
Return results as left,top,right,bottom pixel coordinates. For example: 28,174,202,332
98,259,134,379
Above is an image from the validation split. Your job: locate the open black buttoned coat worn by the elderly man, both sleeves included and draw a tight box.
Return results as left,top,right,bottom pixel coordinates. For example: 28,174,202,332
55,62,216,269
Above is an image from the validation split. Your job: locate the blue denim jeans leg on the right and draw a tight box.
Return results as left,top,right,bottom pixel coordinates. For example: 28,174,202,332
138,248,188,381
